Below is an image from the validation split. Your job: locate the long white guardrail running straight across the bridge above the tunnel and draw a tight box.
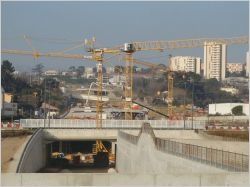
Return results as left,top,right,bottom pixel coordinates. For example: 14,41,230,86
20,119,205,129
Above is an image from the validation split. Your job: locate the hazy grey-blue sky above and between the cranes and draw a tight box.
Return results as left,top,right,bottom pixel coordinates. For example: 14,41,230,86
1,1,249,71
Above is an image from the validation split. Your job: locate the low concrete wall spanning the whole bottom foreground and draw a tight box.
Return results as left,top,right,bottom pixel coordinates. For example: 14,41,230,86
1,173,249,186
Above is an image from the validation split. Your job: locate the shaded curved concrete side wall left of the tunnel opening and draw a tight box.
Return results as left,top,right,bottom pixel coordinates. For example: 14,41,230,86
19,129,46,173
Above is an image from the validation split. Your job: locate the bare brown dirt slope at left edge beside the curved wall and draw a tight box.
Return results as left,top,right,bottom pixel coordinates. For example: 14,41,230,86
1,136,27,172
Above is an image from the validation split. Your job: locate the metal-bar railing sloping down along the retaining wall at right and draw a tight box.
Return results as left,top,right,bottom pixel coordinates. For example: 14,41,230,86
118,124,249,172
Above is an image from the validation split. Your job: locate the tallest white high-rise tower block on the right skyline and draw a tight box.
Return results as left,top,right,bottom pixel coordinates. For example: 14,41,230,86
204,42,227,81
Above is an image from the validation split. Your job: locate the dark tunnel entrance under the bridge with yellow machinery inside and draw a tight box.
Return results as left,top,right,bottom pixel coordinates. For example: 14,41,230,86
39,140,116,173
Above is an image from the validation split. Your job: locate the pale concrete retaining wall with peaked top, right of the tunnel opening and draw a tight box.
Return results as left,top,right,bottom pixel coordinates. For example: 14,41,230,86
116,133,226,174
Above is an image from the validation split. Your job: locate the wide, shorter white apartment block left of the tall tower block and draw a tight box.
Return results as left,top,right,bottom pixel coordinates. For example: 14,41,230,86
170,56,201,74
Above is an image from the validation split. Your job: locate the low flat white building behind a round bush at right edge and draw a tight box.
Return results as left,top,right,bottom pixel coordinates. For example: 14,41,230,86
208,103,249,116
